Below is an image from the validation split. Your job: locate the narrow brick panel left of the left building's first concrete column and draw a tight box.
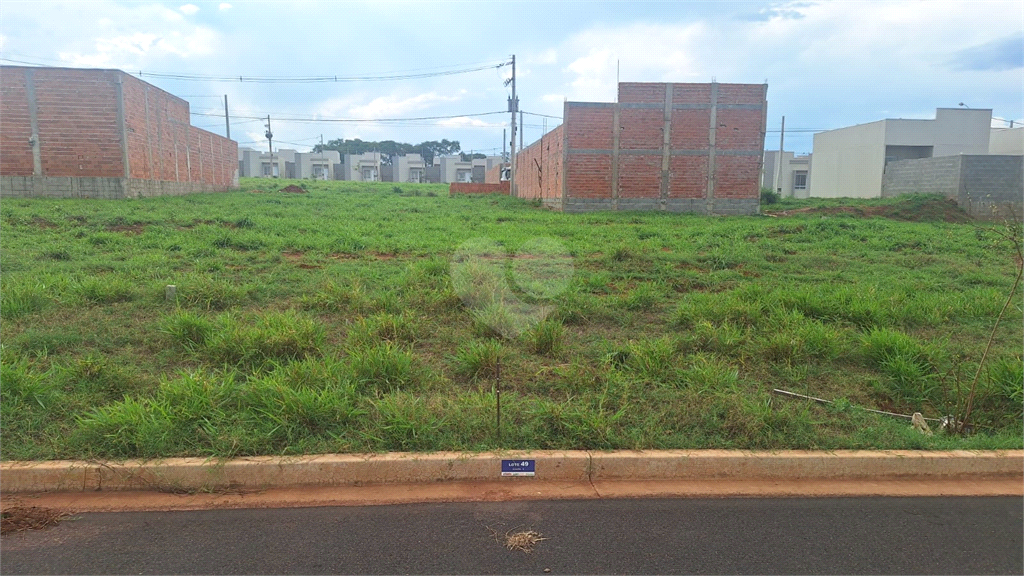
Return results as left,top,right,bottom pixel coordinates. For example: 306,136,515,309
0,67,32,176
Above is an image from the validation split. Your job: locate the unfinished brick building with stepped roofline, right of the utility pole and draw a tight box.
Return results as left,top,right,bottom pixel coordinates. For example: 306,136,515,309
515,82,768,214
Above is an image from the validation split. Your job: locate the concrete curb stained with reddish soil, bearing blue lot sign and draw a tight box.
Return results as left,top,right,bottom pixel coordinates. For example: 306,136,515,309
0,450,1024,494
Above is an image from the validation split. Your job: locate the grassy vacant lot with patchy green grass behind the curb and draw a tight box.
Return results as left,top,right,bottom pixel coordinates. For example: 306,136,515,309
0,180,1024,459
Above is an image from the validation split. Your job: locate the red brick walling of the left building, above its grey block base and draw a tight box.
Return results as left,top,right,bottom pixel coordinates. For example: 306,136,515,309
0,67,238,187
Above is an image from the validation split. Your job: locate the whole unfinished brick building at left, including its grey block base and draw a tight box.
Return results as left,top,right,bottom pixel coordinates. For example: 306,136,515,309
0,66,239,198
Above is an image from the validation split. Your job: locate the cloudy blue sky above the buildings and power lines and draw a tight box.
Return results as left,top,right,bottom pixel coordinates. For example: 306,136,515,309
0,0,1024,153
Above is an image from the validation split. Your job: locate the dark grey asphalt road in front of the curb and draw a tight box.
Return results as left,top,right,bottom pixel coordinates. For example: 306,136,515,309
0,497,1024,574
